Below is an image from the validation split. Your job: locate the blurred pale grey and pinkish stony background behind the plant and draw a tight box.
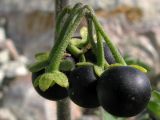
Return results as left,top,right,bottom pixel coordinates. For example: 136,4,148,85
0,0,160,120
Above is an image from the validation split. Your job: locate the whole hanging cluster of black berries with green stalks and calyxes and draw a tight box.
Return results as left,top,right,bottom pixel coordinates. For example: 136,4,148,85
29,3,151,117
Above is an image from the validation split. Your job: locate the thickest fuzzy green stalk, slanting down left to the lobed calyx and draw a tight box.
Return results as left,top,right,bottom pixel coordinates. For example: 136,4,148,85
46,5,86,72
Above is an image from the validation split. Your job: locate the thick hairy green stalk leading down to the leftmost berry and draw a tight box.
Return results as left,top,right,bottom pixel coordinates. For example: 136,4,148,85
46,3,84,72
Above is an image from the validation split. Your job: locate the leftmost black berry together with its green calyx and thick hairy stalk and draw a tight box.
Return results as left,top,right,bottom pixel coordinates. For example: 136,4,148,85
30,4,86,100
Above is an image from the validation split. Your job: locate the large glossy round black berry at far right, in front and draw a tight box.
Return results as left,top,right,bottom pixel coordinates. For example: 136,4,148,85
97,66,151,117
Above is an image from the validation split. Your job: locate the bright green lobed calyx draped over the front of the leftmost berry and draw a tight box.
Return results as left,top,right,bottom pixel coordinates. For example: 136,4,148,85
37,71,69,91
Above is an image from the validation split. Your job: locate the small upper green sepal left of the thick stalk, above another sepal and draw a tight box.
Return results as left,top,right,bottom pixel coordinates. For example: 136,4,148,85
35,52,49,61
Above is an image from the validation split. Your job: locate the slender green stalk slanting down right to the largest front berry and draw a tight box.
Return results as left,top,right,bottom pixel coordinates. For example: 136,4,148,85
88,6,126,65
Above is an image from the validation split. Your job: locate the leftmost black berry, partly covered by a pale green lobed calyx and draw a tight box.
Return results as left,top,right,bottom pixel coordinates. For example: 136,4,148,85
32,69,68,100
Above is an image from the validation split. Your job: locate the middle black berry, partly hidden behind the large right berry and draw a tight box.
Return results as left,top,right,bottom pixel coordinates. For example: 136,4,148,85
68,66,99,108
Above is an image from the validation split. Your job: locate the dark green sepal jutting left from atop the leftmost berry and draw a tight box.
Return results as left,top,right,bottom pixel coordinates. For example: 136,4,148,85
28,60,48,72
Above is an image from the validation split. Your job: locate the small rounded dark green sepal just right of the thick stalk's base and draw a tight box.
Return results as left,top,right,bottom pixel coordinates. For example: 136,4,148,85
60,60,75,71
